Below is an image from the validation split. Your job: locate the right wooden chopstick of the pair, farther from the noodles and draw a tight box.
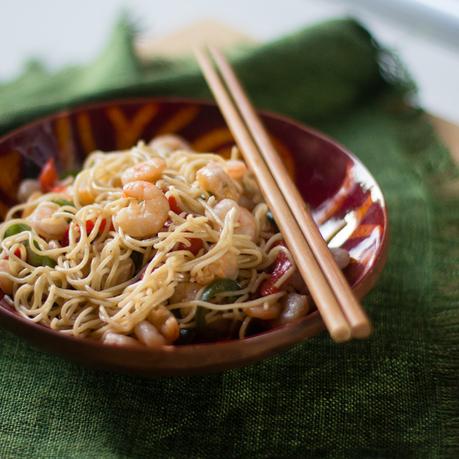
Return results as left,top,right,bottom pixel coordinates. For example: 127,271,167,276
209,47,372,338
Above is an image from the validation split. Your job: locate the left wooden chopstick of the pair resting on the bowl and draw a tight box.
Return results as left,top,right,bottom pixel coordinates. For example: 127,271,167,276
195,49,351,342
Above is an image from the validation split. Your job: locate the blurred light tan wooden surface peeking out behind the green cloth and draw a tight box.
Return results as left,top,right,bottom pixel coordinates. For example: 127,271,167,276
136,20,459,163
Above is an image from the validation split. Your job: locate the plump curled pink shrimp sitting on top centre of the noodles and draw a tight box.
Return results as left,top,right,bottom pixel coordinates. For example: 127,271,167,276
114,181,169,238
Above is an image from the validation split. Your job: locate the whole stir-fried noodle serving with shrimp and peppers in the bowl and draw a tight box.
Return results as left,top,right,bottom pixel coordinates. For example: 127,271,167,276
0,136,349,347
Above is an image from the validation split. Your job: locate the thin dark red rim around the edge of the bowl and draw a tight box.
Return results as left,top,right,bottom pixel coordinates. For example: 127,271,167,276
0,96,389,356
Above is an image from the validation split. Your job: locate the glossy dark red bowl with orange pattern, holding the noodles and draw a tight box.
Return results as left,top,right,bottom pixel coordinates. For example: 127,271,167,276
0,98,388,376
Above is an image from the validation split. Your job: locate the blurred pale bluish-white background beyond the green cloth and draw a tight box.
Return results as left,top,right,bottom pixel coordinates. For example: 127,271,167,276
0,0,459,123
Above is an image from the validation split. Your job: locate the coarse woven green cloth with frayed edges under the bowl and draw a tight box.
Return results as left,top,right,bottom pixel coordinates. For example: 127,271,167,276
0,16,459,458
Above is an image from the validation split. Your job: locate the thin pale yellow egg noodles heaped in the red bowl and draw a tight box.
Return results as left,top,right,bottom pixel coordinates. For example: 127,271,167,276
0,136,295,339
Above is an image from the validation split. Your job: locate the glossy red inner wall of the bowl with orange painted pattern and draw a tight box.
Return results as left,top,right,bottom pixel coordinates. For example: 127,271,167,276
0,99,387,307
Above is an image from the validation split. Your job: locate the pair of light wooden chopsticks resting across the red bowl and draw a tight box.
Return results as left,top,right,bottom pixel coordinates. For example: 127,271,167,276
195,47,371,342
